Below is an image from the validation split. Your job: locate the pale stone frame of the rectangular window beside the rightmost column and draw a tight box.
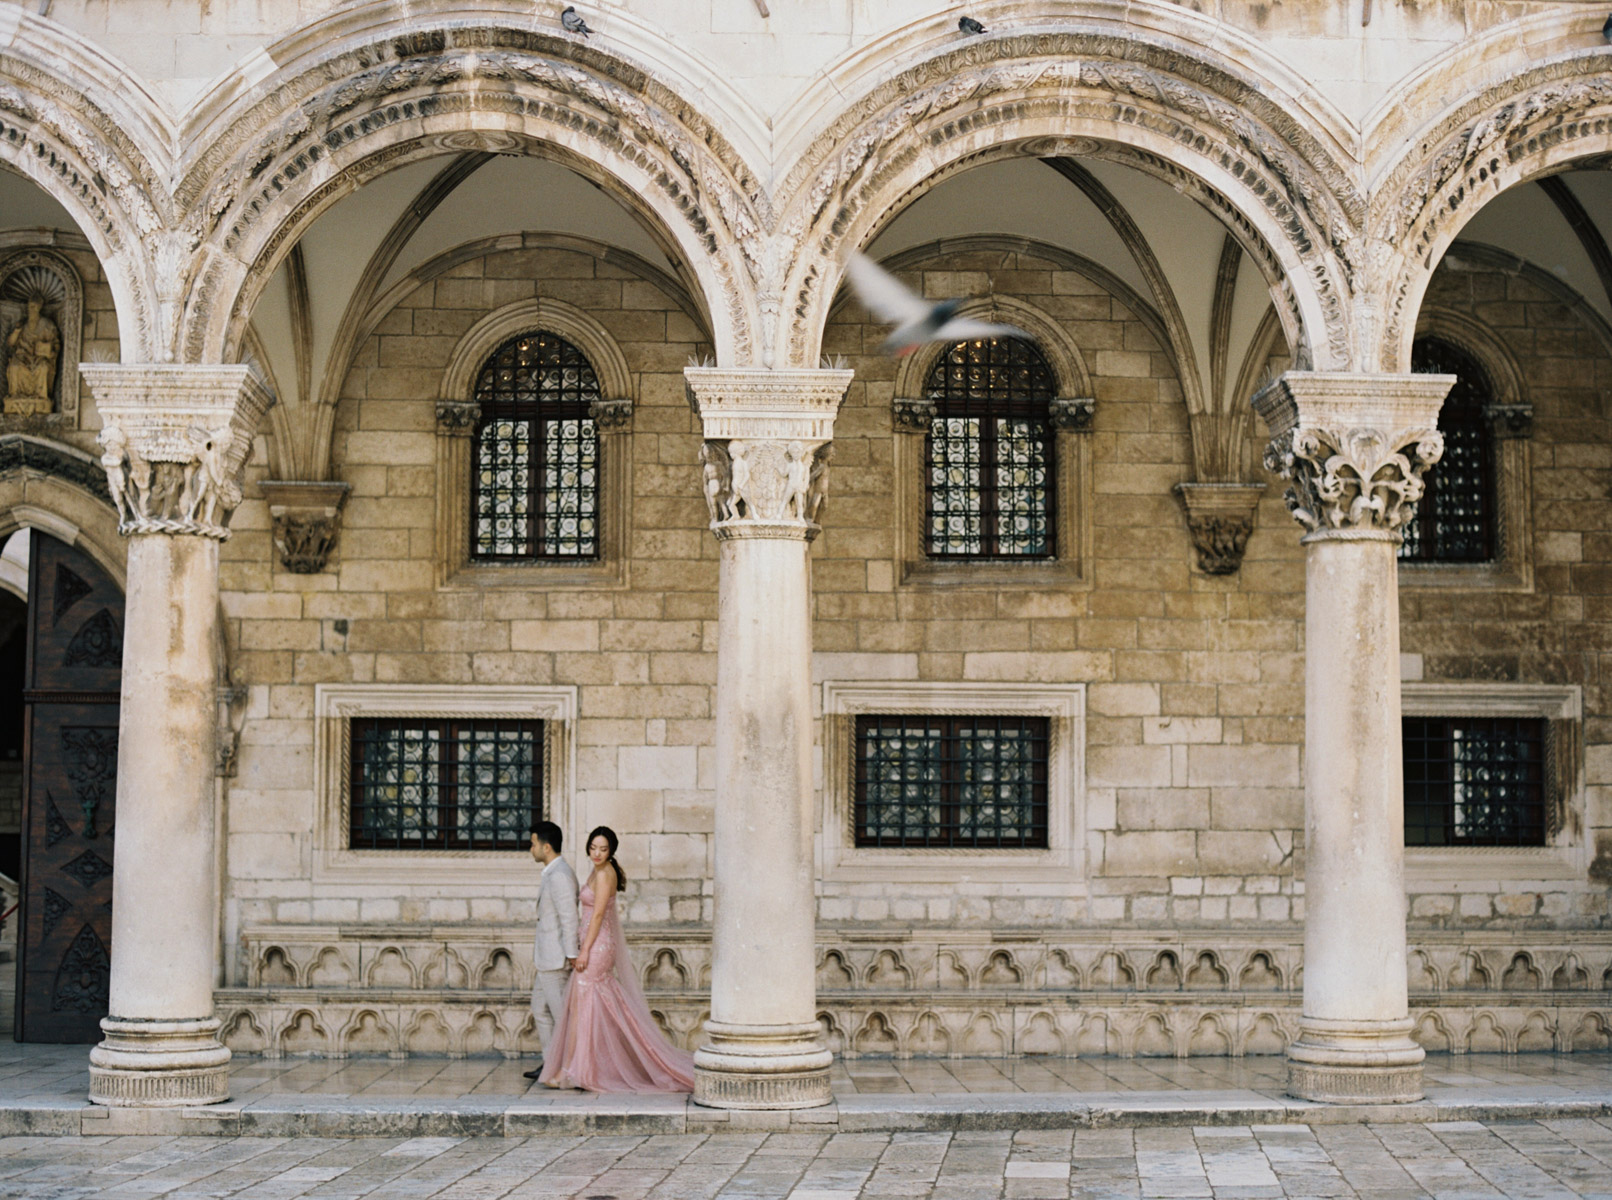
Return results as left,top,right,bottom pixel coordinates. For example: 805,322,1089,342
1399,683,1589,892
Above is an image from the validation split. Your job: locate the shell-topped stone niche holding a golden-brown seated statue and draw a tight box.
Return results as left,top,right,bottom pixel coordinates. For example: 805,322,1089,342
0,250,84,427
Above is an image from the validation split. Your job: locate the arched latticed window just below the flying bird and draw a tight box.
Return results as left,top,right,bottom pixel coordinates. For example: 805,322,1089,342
924,339,1057,560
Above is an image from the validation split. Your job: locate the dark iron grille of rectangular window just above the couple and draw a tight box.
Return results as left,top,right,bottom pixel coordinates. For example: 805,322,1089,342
348,718,543,850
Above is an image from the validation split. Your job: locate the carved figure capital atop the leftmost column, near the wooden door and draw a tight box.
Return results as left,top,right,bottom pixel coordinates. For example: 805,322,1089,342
79,363,274,542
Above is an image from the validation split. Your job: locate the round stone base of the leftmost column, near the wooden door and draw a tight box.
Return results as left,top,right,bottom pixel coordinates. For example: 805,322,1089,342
90,1016,229,1108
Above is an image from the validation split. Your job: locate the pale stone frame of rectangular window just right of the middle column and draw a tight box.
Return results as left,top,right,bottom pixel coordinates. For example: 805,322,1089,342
819,679,1086,895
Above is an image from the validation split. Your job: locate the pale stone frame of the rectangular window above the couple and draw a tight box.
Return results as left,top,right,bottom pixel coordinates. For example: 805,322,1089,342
311,684,577,887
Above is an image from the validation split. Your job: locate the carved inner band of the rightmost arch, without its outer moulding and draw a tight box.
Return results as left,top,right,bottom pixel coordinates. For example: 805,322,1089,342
1362,34,1612,371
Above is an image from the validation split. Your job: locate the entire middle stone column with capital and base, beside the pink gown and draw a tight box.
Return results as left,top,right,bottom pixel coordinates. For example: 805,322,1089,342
683,368,851,1108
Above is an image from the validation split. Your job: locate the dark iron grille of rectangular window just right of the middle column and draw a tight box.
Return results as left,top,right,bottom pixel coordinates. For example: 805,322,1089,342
853,715,1051,850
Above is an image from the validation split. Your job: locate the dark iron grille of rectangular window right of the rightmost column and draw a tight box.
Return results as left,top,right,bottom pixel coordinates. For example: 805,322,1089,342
1402,716,1554,847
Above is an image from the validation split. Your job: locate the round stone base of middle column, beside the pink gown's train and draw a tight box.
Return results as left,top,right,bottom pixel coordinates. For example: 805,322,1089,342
695,1021,833,1110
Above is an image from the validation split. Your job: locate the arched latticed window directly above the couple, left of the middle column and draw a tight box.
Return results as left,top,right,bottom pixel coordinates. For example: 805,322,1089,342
471,332,600,563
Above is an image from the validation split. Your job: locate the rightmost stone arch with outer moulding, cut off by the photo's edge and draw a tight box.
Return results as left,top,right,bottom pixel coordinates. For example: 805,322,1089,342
1361,21,1612,371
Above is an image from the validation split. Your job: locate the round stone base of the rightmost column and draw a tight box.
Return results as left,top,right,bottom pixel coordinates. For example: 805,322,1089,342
1288,1018,1427,1105
